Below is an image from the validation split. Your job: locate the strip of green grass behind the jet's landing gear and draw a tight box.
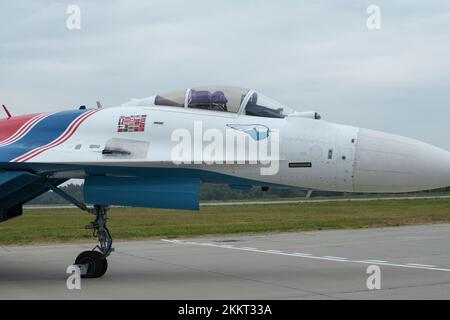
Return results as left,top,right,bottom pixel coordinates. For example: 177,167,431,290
0,199,450,245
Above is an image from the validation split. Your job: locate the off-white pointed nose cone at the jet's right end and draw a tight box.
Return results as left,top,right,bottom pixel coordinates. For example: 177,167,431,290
353,129,450,192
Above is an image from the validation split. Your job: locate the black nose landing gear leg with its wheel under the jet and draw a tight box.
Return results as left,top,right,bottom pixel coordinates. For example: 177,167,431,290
75,205,114,278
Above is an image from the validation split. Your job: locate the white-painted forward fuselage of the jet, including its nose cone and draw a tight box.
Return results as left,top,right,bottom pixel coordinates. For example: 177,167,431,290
30,106,450,192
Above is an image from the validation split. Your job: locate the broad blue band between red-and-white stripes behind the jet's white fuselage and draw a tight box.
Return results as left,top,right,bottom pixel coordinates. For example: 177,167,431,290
0,109,89,162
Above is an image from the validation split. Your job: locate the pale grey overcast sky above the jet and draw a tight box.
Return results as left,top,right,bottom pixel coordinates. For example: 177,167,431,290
0,0,450,150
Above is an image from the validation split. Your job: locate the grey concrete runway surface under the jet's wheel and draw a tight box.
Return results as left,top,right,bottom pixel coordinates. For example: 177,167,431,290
0,224,450,300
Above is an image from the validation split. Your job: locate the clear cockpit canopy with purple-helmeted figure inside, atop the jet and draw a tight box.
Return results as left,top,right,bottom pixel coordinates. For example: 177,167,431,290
154,86,293,118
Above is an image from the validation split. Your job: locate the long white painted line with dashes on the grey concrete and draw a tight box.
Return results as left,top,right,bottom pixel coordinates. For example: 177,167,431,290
161,239,450,272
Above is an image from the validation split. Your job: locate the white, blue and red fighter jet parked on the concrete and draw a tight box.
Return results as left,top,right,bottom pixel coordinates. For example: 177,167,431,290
0,86,450,278
